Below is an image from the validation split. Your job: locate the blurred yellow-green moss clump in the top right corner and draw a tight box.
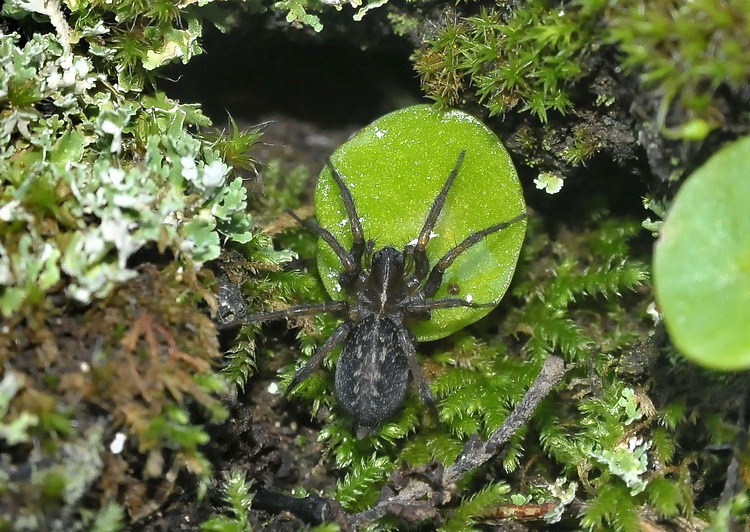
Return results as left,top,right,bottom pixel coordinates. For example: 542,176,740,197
605,0,750,128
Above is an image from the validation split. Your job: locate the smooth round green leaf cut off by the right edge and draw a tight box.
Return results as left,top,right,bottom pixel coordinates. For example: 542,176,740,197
654,137,750,370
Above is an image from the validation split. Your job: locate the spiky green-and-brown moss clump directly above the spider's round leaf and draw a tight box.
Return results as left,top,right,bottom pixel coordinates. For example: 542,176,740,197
414,0,601,122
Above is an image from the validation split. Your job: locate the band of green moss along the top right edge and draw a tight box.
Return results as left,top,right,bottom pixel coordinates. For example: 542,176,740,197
414,0,750,131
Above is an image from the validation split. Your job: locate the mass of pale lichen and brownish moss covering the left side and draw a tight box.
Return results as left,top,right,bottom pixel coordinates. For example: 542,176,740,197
0,1,284,531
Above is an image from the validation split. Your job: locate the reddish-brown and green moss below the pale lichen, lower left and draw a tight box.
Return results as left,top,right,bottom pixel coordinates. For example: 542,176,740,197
0,265,226,530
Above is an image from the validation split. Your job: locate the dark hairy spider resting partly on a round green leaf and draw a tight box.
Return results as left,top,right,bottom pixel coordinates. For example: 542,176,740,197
222,150,526,434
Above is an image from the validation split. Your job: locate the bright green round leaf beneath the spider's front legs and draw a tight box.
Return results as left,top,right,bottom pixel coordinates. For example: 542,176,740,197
315,105,526,341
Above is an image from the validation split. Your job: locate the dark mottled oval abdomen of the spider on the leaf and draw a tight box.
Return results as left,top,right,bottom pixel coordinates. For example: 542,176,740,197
336,315,409,427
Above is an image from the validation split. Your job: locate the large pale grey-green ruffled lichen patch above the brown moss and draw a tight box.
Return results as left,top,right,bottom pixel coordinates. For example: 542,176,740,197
0,30,251,316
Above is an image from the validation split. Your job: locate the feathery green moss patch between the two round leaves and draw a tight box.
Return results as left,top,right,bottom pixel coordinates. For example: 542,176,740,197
508,215,648,361
